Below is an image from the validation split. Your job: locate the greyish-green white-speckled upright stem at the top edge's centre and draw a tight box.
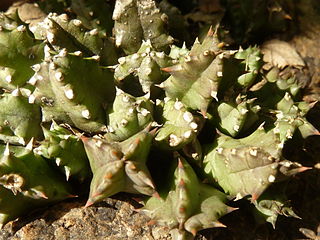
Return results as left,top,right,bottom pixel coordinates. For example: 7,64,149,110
112,0,173,54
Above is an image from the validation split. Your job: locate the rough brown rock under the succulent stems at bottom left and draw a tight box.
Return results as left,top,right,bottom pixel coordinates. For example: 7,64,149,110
0,196,205,240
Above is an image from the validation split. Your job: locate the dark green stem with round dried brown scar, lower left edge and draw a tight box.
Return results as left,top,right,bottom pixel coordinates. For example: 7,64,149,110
0,139,72,225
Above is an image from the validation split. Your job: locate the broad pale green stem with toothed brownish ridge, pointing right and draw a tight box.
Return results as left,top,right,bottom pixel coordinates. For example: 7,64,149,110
204,126,307,200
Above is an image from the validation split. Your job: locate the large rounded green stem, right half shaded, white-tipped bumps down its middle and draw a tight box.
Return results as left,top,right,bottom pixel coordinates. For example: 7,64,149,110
29,46,115,132
